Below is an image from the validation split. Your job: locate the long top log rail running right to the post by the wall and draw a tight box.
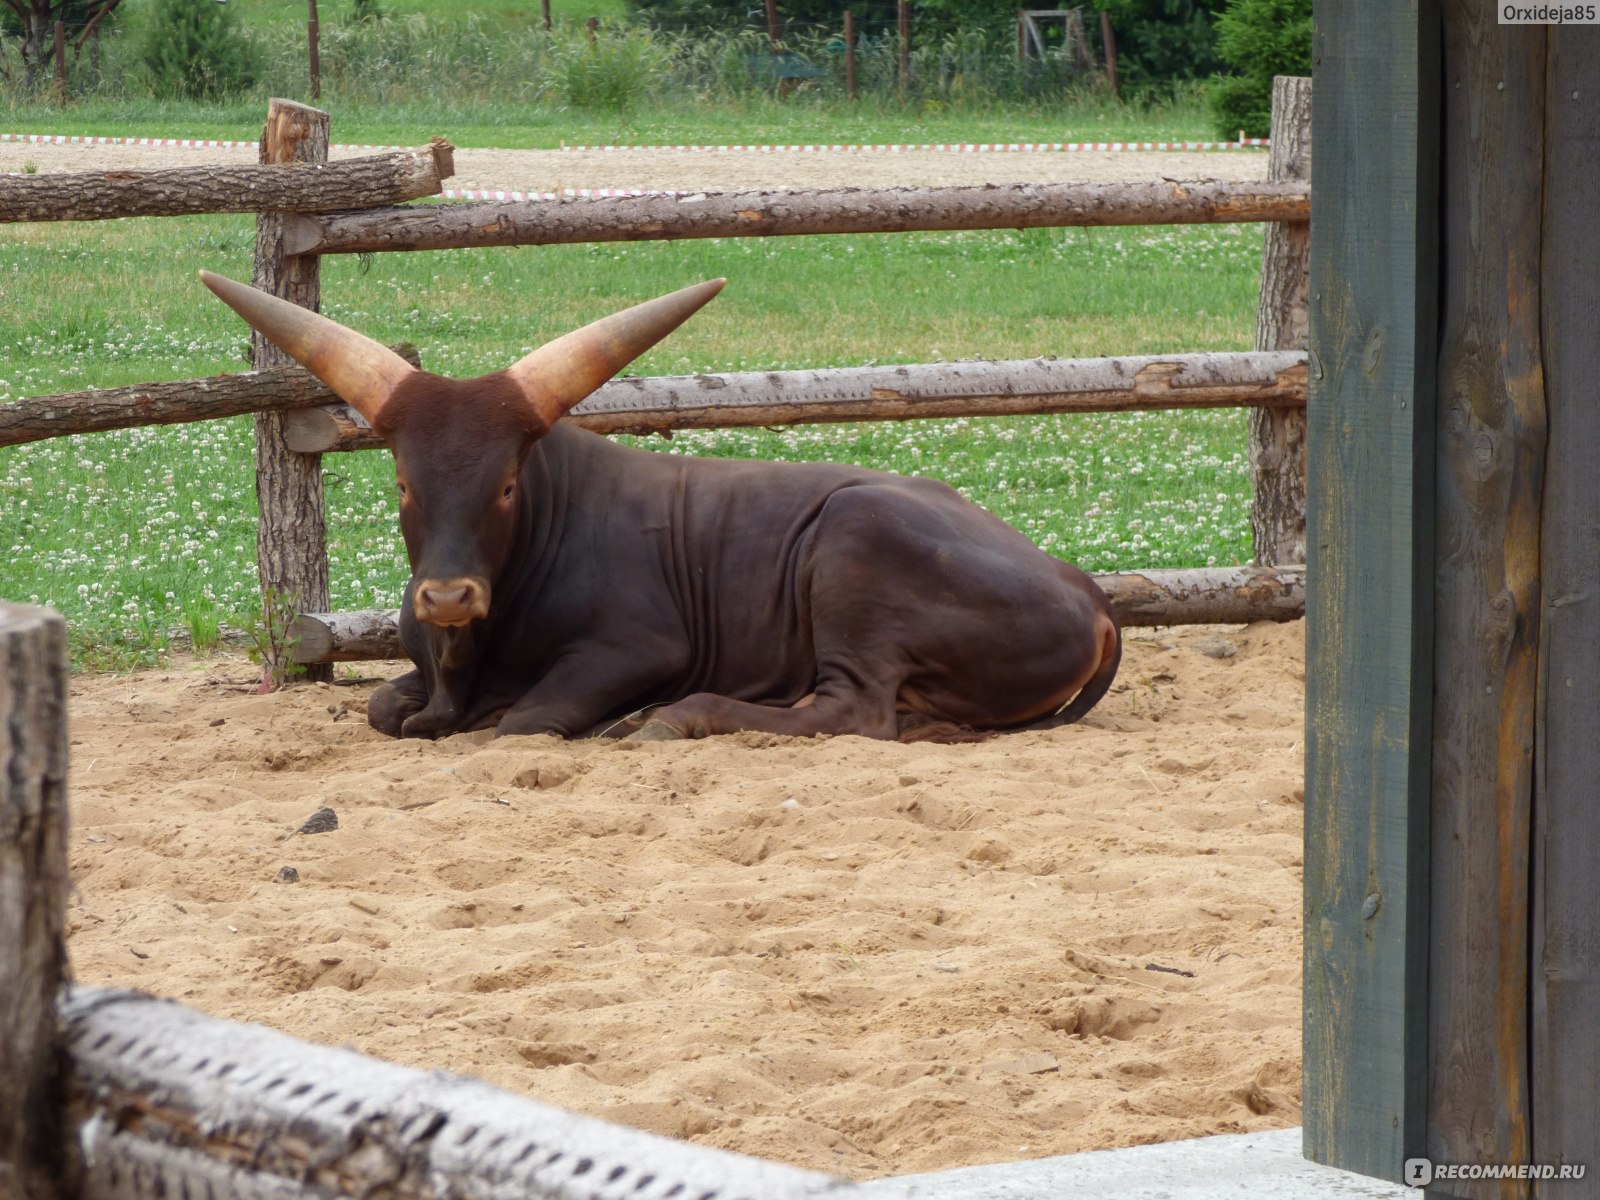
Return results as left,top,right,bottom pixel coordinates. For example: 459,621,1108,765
285,179,1310,254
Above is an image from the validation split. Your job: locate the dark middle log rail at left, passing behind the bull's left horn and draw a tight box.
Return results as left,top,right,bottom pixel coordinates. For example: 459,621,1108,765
0,344,421,446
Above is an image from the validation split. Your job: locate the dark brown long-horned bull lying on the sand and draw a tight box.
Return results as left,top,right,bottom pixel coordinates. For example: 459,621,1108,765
202,272,1122,738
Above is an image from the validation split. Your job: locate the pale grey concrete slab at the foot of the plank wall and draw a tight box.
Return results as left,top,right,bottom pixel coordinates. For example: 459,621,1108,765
861,1130,1421,1200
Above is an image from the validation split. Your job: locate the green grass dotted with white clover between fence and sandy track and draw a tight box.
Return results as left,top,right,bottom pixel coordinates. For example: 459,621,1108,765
0,209,1261,666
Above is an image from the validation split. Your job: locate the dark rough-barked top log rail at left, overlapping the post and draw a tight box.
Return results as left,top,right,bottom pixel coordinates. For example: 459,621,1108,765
0,138,456,222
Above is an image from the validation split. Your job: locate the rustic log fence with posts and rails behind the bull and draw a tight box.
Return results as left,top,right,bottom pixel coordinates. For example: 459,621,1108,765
0,80,1310,678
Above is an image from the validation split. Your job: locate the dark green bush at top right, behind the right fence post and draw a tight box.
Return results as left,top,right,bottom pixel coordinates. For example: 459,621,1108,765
1210,0,1312,138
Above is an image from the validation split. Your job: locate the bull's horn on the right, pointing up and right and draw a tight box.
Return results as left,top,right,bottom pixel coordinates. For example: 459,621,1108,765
506,278,726,426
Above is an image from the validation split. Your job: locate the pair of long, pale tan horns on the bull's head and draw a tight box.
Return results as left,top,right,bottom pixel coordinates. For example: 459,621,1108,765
200,270,726,430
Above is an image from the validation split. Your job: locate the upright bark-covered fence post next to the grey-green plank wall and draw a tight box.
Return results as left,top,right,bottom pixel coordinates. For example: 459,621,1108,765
1250,75,1310,566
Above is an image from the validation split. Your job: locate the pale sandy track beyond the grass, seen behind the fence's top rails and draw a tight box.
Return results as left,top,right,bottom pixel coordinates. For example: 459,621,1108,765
0,134,1267,192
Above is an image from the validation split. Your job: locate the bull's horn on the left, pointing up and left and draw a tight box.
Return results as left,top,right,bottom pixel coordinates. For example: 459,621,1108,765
200,270,416,426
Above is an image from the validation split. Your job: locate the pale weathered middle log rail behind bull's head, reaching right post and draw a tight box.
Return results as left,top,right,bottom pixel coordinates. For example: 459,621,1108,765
286,352,1306,451
